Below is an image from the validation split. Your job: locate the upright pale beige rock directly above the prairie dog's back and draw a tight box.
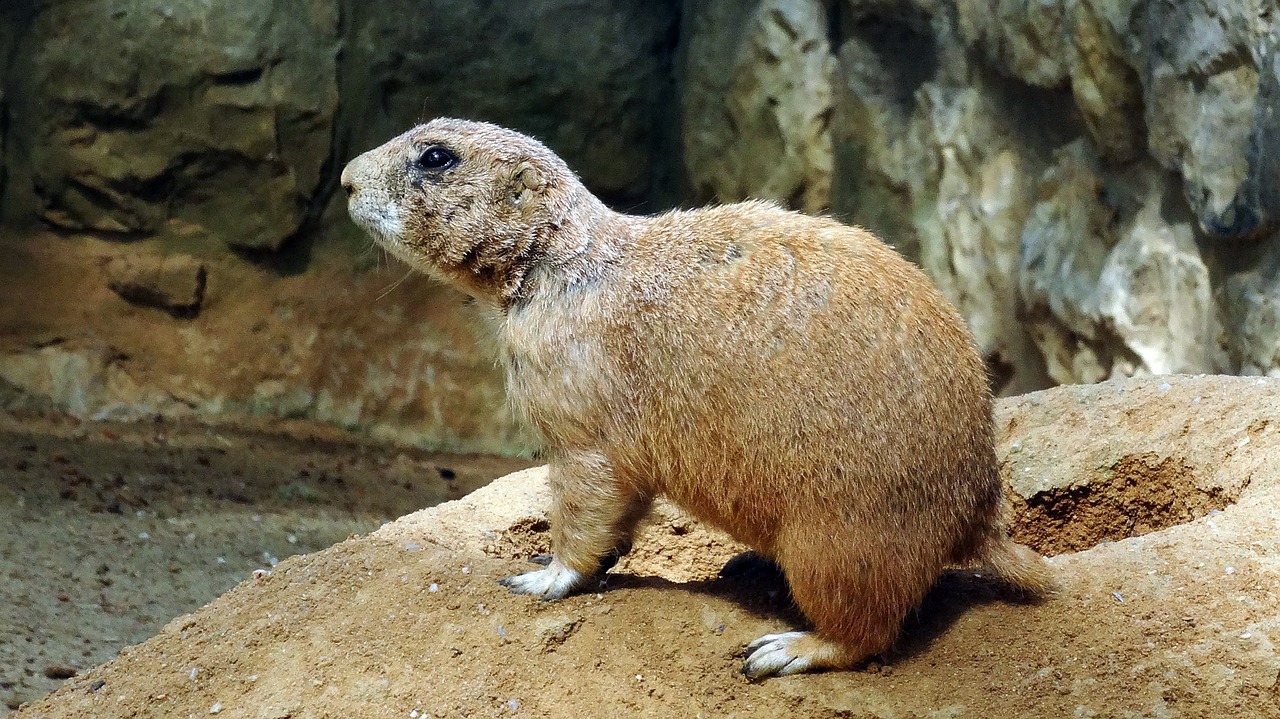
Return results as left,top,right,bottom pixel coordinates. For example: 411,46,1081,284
680,0,835,212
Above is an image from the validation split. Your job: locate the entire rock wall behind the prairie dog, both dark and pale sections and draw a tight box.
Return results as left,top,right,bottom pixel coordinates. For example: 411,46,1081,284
0,0,1280,453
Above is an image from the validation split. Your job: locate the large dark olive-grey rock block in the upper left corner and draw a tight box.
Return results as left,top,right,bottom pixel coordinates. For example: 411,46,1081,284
10,0,339,249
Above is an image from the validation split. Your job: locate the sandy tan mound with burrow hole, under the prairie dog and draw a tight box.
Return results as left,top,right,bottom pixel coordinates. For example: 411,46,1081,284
18,377,1280,719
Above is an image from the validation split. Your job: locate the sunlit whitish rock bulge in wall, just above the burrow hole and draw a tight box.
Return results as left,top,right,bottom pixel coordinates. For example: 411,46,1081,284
1019,142,1225,384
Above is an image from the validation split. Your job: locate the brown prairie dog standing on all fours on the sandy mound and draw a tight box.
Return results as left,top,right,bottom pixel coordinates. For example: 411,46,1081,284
342,119,1053,678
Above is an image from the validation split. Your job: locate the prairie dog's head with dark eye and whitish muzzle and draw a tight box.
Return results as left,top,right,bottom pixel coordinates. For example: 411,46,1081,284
342,119,594,306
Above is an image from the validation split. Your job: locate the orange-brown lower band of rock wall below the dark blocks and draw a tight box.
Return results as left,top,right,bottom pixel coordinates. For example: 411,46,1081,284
0,241,529,454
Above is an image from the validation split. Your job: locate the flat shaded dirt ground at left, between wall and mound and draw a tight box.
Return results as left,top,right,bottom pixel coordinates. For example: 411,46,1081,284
0,413,527,715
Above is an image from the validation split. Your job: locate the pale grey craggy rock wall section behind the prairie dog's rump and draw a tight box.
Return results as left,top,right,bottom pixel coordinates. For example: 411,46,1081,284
833,0,1280,389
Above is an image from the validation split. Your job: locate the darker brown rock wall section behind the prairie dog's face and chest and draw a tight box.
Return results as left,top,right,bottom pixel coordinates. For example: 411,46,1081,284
0,0,678,453
